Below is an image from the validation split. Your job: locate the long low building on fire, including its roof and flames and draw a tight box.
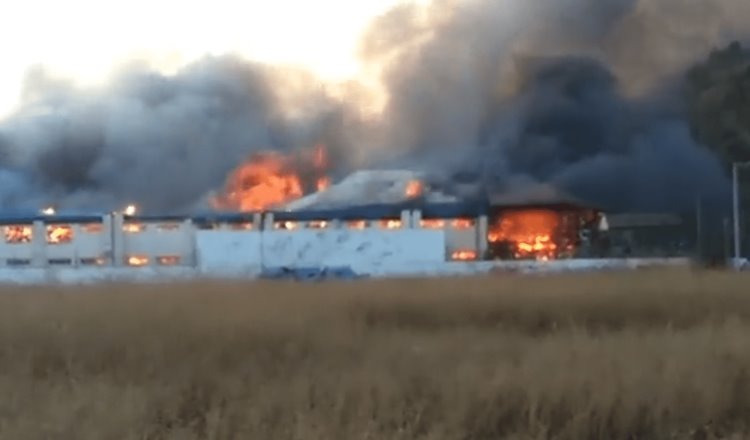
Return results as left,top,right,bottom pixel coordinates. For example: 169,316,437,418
0,145,692,272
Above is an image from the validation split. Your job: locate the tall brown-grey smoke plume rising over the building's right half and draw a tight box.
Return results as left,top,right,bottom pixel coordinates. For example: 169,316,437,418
362,0,750,210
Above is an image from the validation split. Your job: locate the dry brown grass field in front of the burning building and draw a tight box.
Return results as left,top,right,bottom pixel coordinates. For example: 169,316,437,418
0,271,750,440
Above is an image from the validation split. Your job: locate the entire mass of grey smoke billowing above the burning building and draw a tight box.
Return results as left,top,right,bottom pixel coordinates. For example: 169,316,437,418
0,0,750,212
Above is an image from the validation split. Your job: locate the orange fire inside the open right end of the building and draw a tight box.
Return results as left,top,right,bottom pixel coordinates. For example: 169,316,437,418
487,209,560,260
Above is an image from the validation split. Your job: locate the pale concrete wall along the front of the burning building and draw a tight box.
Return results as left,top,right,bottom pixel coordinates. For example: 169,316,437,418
0,211,700,283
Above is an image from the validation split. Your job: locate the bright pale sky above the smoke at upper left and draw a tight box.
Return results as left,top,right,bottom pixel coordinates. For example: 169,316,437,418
0,0,418,118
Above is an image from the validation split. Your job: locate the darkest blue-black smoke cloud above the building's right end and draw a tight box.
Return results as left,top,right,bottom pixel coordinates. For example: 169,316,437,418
479,58,727,211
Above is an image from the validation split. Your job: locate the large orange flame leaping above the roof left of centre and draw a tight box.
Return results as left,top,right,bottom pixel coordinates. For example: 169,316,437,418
211,145,330,212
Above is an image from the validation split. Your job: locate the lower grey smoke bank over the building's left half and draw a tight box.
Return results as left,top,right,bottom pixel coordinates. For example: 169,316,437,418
0,58,356,212
